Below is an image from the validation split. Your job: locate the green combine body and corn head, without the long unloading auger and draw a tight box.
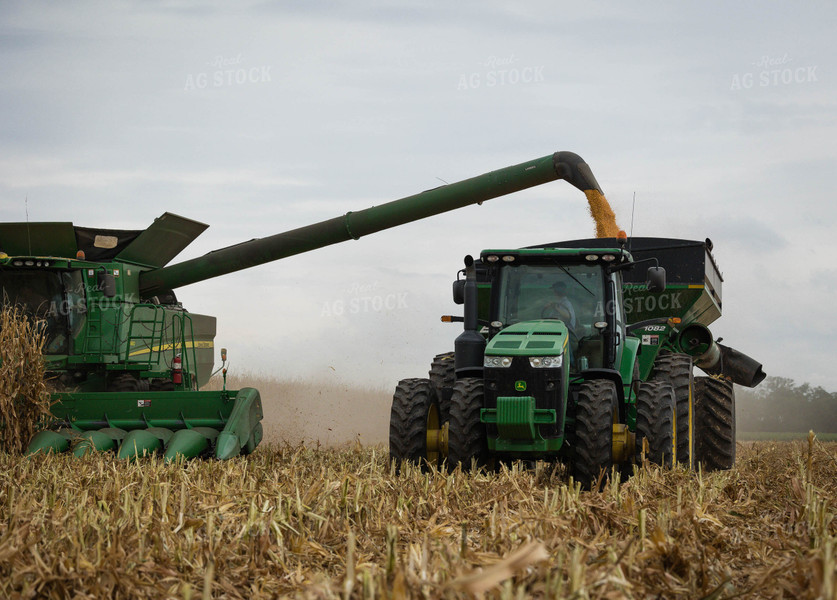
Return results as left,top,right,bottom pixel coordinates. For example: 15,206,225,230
0,213,262,459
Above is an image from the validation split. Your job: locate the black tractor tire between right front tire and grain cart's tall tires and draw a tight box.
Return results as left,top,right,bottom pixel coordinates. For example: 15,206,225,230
636,380,676,466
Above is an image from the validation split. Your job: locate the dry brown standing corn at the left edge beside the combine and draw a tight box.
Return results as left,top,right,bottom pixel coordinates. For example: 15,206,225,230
0,304,50,453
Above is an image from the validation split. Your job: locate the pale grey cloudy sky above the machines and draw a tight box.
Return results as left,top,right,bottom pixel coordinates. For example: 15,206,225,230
0,0,837,391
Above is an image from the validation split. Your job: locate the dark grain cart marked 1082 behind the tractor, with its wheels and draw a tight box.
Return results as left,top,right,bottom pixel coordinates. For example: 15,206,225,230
553,238,765,470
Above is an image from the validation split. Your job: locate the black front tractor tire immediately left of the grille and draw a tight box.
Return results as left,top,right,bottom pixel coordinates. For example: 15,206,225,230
448,377,488,470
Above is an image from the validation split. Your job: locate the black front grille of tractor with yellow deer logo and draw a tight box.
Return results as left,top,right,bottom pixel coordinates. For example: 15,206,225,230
484,356,564,438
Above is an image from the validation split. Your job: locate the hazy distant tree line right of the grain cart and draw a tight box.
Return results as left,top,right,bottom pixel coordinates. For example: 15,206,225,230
735,377,837,433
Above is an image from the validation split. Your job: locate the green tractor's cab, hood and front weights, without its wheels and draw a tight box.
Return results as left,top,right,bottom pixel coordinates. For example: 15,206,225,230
465,248,633,453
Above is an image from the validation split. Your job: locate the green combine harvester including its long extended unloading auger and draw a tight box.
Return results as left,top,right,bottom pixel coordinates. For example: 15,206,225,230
0,152,598,459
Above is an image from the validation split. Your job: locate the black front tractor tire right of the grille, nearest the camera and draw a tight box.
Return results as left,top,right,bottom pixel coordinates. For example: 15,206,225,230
569,379,618,490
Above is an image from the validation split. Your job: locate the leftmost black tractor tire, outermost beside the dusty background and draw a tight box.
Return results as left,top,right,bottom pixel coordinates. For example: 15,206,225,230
389,379,439,470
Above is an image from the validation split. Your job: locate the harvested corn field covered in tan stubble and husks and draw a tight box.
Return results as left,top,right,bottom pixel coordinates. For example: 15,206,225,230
0,441,837,598
